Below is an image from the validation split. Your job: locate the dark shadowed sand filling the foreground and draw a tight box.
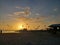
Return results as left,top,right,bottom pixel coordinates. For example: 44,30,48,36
0,32,60,45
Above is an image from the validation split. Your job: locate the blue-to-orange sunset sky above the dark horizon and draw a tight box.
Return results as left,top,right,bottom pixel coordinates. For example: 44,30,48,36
0,0,60,30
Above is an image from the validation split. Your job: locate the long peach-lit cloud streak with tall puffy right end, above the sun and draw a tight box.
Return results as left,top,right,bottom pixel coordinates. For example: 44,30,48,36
8,8,31,17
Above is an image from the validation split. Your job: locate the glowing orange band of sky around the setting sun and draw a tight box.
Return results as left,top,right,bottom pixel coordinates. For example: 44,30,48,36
0,18,56,30
